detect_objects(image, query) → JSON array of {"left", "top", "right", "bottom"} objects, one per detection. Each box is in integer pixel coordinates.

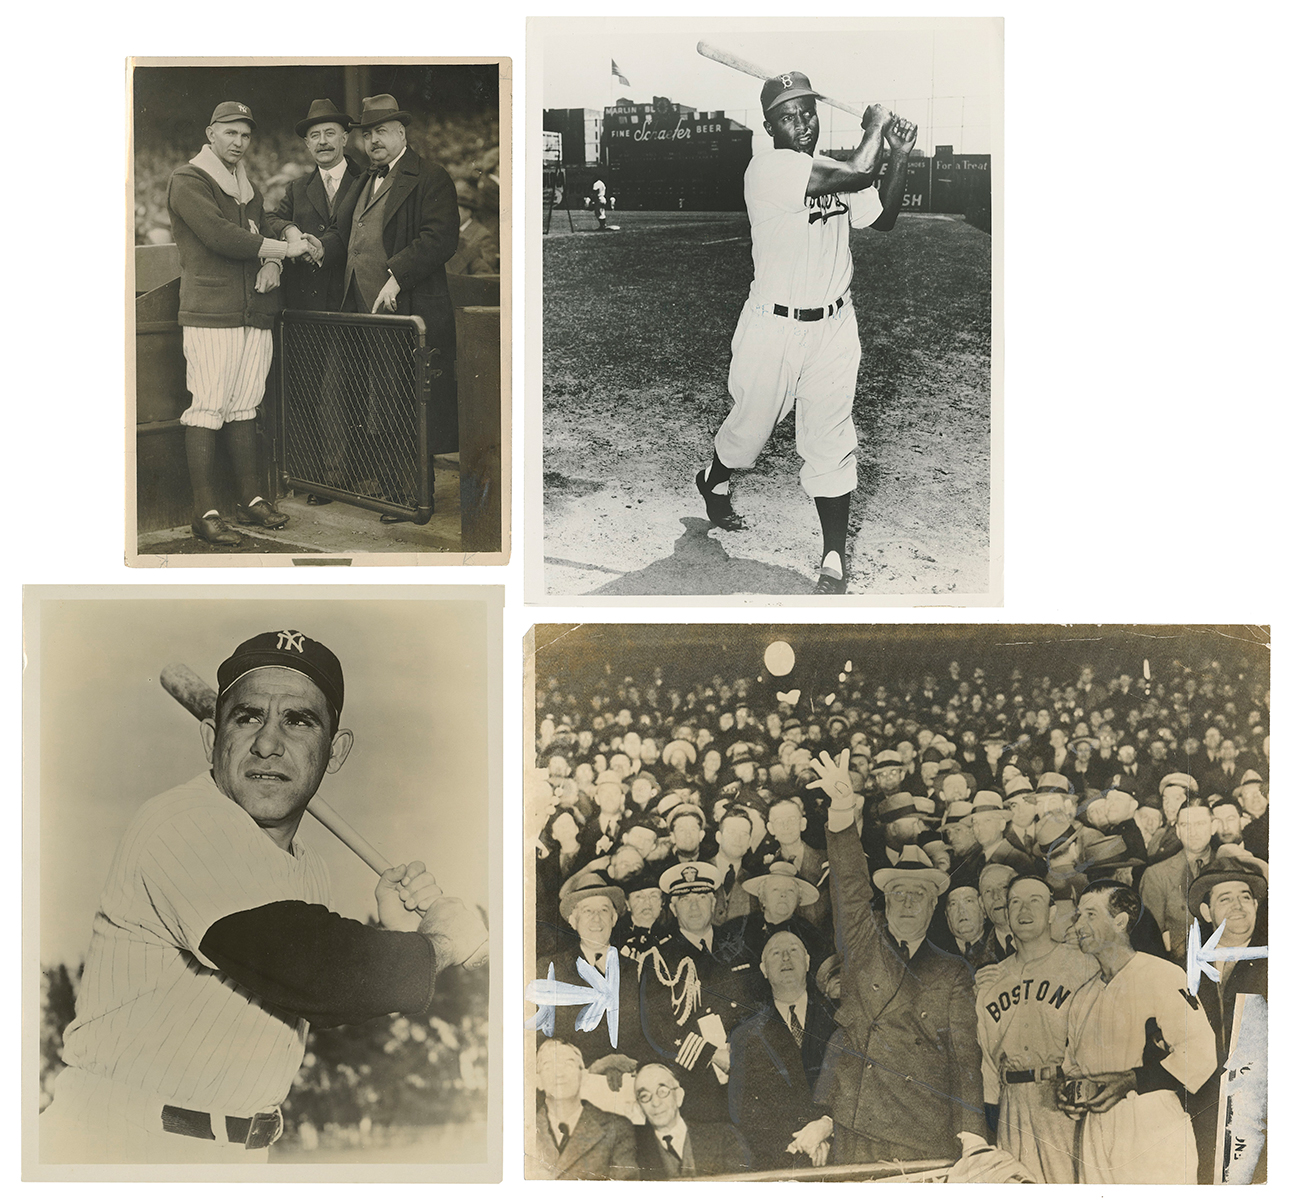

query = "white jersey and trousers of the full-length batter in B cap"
[{"left": 713, "top": 150, "right": 884, "bottom": 497}]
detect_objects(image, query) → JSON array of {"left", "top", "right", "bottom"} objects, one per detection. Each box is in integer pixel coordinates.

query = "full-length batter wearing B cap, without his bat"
[{"left": 695, "top": 71, "right": 916, "bottom": 594}]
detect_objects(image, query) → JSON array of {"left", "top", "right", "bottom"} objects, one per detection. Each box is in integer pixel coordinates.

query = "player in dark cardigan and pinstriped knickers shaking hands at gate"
[{"left": 167, "top": 99, "right": 310, "bottom": 546}]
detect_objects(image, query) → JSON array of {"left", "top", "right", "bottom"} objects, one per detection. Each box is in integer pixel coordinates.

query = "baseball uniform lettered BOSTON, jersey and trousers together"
[{"left": 975, "top": 942, "right": 1099, "bottom": 1183}]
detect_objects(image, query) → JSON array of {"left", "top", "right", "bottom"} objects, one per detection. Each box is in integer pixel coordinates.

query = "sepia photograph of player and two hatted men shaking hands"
[{"left": 127, "top": 58, "right": 512, "bottom": 567}]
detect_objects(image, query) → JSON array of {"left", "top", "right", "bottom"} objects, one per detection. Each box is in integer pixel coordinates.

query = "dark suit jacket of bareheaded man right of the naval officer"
[{"left": 727, "top": 993, "right": 836, "bottom": 1170}]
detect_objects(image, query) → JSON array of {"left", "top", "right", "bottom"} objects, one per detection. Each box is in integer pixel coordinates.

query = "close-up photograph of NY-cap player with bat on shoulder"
[{"left": 25, "top": 589, "right": 501, "bottom": 1181}]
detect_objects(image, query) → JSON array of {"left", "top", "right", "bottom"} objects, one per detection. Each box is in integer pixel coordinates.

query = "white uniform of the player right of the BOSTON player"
[{"left": 1063, "top": 953, "right": 1216, "bottom": 1183}]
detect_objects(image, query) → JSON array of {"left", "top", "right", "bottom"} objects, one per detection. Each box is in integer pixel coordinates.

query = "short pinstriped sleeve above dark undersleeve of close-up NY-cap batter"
[{"left": 136, "top": 801, "right": 325, "bottom": 967}]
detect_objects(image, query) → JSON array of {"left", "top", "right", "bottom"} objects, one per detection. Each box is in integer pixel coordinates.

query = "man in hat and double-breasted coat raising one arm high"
[{"left": 814, "top": 750, "right": 987, "bottom": 1163}]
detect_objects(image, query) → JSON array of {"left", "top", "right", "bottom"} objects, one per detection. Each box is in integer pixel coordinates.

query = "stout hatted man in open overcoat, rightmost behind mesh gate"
[{"left": 337, "top": 94, "right": 457, "bottom": 523}]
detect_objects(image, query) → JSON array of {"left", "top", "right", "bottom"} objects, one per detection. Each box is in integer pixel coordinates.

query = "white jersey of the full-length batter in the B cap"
[{"left": 744, "top": 150, "right": 884, "bottom": 309}]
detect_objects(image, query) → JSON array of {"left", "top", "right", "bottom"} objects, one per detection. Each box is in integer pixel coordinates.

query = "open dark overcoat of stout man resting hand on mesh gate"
[{"left": 324, "top": 146, "right": 457, "bottom": 358}]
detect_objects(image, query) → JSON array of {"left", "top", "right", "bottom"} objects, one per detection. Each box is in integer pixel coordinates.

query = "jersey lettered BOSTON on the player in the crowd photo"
[{"left": 974, "top": 942, "right": 1099, "bottom": 1104}]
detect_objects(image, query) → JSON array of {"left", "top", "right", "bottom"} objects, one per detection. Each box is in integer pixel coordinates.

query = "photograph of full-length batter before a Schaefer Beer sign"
[{"left": 525, "top": 17, "right": 1004, "bottom": 596}]
